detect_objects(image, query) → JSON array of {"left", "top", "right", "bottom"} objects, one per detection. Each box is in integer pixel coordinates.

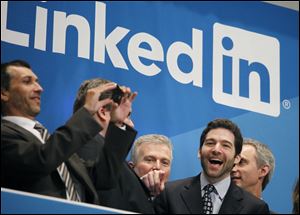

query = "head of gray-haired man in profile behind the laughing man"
[{"left": 231, "top": 138, "right": 275, "bottom": 198}]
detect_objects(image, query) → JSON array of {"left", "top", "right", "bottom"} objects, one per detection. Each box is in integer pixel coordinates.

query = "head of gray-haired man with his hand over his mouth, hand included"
[{"left": 129, "top": 134, "right": 173, "bottom": 197}]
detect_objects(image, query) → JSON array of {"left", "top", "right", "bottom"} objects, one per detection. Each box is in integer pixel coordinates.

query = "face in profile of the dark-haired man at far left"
[{"left": 1, "top": 66, "right": 43, "bottom": 119}]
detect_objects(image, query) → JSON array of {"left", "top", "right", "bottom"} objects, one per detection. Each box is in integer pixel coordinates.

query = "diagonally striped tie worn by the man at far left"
[{"left": 34, "top": 123, "right": 81, "bottom": 202}]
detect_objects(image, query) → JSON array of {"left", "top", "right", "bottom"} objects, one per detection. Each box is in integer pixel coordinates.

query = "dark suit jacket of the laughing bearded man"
[{"left": 154, "top": 175, "right": 269, "bottom": 214}]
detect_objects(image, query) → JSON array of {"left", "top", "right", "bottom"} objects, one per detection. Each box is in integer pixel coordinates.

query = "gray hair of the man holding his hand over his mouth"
[{"left": 131, "top": 134, "right": 173, "bottom": 163}]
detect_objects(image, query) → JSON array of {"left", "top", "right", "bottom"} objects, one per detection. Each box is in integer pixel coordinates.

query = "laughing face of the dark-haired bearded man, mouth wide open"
[{"left": 199, "top": 128, "right": 235, "bottom": 183}]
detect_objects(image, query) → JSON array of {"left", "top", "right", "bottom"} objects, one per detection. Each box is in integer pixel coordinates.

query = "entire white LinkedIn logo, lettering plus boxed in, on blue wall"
[{"left": 1, "top": 1, "right": 280, "bottom": 117}]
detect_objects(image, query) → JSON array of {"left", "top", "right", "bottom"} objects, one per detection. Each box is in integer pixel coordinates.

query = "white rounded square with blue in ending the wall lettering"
[{"left": 213, "top": 23, "right": 280, "bottom": 117}]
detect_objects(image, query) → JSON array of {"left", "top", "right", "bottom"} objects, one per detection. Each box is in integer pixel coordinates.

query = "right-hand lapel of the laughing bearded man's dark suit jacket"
[{"left": 219, "top": 181, "right": 243, "bottom": 214}]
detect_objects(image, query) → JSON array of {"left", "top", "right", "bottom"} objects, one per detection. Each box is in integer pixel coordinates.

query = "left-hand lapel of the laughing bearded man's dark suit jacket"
[{"left": 180, "top": 175, "right": 203, "bottom": 214}]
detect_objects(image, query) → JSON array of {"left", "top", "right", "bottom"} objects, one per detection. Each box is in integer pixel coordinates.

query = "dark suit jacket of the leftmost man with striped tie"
[{"left": 1, "top": 108, "right": 132, "bottom": 204}]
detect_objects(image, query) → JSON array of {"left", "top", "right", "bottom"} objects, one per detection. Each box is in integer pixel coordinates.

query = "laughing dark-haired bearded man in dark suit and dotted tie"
[{"left": 155, "top": 119, "right": 269, "bottom": 214}]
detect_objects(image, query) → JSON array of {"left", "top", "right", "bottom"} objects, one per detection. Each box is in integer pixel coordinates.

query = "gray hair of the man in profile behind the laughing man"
[{"left": 243, "top": 138, "right": 275, "bottom": 190}]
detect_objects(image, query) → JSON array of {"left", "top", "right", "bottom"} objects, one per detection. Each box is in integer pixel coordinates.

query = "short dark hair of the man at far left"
[{"left": 1, "top": 60, "right": 31, "bottom": 116}]
